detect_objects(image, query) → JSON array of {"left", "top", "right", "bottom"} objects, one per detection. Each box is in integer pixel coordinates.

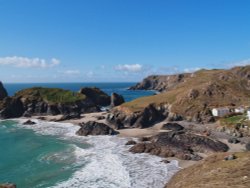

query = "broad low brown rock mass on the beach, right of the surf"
[{"left": 130, "top": 131, "right": 229, "bottom": 160}]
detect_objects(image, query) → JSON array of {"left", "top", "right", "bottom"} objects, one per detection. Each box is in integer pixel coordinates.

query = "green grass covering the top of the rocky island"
[{"left": 15, "top": 87, "right": 86, "bottom": 104}]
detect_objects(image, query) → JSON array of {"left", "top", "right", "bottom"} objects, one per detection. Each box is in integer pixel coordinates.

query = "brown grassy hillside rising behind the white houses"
[{"left": 122, "top": 66, "right": 250, "bottom": 116}]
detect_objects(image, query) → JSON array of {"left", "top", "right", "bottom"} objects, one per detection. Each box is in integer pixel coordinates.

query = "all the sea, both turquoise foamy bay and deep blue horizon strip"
[{"left": 0, "top": 83, "right": 180, "bottom": 188}]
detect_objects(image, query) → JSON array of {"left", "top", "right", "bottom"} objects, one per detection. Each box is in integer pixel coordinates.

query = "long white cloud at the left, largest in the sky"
[{"left": 0, "top": 56, "right": 60, "bottom": 68}]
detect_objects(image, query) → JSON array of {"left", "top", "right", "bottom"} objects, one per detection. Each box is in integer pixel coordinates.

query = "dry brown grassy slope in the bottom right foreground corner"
[{"left": 165, "top": 152, "right": 250, "bottom": 188}]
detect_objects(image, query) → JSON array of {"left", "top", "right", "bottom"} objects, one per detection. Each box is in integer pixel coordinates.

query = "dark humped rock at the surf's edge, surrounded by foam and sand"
[{"left": 76, "top": 121, "right": 119, "bottom": 136}]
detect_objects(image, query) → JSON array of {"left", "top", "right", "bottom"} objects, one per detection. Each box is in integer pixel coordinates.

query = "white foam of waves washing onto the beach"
[{"left": 14, "top": 120, "right": 179, "bottom": 188}]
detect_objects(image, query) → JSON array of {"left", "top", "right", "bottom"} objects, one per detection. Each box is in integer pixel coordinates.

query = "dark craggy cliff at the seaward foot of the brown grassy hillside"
[{"left": 106, "top": 105, "right": 169, "bottom": 129}]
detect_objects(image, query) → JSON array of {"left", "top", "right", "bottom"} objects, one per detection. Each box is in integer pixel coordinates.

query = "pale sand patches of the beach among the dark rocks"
[{"left": 21, "top": 112, "right": 247, "bottom": 169}]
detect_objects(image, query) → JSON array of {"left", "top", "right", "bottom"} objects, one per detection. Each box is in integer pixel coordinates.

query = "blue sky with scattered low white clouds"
[{"left": 0, "top": 0, "right": 250, "bottom": 83}]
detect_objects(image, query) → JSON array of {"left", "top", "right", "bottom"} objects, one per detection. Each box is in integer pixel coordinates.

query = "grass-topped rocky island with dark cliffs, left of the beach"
[{"left": 0, "top": 88, "right": 110, "bottom": 118}]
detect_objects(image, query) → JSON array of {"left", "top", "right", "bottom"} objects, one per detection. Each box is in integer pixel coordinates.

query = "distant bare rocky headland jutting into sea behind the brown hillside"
[{"left": 129, "top": 73, "right": 192, "bottom": 92}]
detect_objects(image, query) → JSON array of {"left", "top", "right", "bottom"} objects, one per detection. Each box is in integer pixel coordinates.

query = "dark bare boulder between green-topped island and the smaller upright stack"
[{"left": 79, "top": 87, "right": 110, "bottom": 106}]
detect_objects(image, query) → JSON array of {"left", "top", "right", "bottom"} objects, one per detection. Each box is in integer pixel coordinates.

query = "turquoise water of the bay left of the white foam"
[{"left": 0, "top": 120, "right": 88, "bottom": 188}]
